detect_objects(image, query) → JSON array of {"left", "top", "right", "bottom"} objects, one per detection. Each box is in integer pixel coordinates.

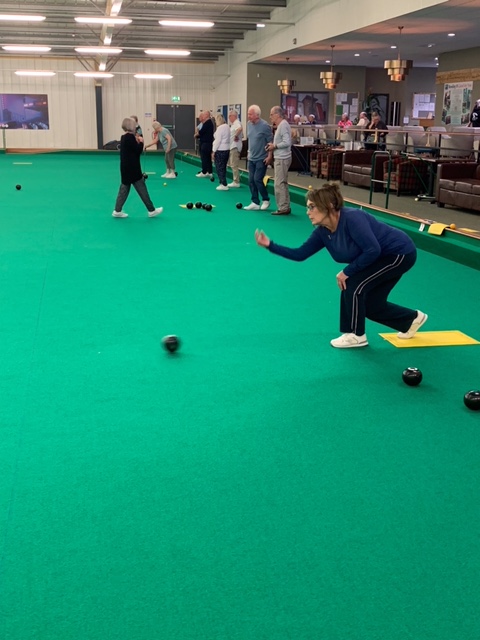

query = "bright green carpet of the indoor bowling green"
[{"left": 0, "top": 152, "right": 480, "bottom": 640}]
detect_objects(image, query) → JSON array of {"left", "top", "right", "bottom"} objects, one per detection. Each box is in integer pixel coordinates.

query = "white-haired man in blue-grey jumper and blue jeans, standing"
[{"left": 244, "top": 104, "right": 273, "bottom": 211}]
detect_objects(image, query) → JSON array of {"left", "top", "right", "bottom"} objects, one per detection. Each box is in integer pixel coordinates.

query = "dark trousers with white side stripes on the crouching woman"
[{"left": 340, "top": 252, "right": 417, "bottom": 336}]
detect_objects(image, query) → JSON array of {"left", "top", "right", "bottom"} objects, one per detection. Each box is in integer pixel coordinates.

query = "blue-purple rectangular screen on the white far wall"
[{"left": 0, "top": 93, "right": 50, "bottom": 131}]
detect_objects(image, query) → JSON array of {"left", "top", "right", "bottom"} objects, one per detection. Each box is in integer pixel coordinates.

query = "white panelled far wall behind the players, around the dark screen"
[{"left": 0, "top": 56, "right": 216, "bottom": 149}]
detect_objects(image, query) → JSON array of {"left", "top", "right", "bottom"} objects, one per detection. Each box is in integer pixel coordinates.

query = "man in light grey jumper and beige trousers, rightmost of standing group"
[{"left": 267, "top": 106, "right": 292, "bottom": 216}]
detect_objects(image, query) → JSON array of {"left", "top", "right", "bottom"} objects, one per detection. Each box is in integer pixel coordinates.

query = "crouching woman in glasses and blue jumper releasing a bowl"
[{"left": 255, "top": 183, "right": 428, "bottom": 349}]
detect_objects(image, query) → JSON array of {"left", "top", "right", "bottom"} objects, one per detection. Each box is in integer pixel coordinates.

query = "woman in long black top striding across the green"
[{"left": 112, "top": 118, "right": 163, "bottom": 218}]
